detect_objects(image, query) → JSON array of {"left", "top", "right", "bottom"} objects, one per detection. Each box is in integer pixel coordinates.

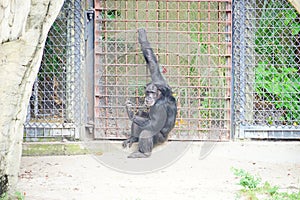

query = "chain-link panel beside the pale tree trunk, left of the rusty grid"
[{"left": 24, "top": 0, "right": 82, "bottom": 139}]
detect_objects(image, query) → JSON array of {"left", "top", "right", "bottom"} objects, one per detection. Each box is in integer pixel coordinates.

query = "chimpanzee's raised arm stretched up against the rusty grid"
[{"left": 138, "top": 28, "right": 167, "bottom": 86}]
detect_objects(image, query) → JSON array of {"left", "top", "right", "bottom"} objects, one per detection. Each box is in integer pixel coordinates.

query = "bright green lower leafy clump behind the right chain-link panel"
[{"left": 255, "top": 61, "right": 300, "bottom": 121}]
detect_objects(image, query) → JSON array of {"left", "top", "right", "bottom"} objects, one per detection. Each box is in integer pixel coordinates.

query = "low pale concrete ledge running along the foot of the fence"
[{"left": 23, "top": 140, "right": 300, "bottom": 163}]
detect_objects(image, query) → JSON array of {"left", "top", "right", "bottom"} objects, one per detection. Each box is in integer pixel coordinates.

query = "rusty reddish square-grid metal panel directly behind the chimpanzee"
[{"left": 95, "top": 0, "right": 231, "bottom": 140}]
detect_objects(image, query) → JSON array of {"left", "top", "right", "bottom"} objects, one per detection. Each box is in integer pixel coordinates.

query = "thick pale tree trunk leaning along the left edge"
[{"left": 0, "top": 0, "right": 63, "bottom": 196}]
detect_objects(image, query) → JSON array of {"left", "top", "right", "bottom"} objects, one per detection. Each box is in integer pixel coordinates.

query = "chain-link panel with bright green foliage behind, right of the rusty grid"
[{"left": 233, "top": 0, "right": 300, "bottom": 138}]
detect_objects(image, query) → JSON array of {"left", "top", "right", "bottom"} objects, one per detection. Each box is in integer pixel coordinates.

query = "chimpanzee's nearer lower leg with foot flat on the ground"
[{"left": 128, "top": 130, "right": 153, "bottom": 158}]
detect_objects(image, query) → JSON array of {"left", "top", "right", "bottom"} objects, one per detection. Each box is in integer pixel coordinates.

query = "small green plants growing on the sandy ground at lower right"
[{"left": 232, "top": 168, "right": 300, "bottom": 200}]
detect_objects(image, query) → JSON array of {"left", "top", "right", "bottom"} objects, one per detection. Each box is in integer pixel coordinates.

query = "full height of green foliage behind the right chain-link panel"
[{"left": 255, "top": 1, "right": 300, "bottom": 124}]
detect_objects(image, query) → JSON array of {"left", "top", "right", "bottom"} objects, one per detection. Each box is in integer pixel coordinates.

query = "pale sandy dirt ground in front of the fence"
[{"left": 17, "top": 142, "right": 300, "bottom": 200}]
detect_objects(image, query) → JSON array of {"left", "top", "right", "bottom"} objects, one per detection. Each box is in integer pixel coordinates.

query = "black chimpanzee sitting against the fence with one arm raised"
[{"left": 123, "top": 29, "right": 177, "bottom": 158}]
